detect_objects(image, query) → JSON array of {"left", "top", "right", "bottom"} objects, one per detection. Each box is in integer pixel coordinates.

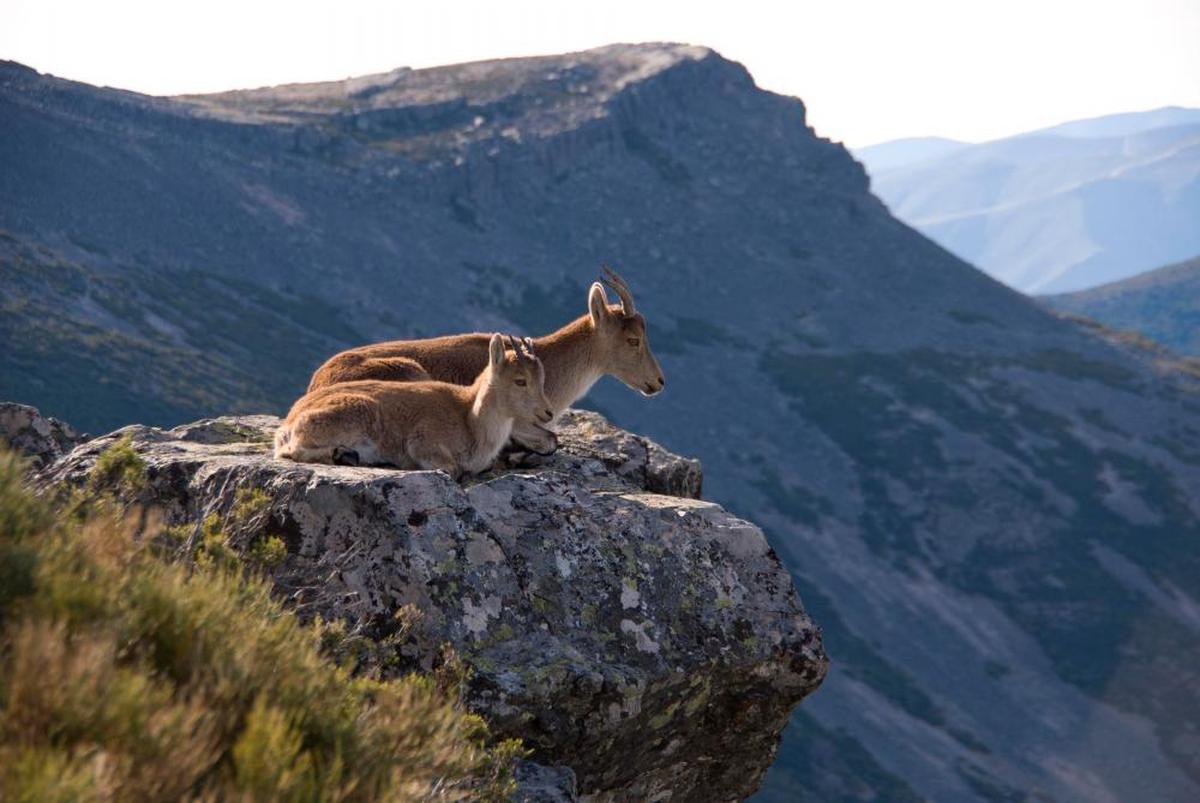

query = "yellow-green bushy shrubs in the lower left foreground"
[{"left": 0, "top": 447, "right": 520, "bottom": 803}]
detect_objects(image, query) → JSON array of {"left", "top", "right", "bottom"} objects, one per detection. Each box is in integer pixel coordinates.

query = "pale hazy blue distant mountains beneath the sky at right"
[{"left": 864, "top": 108, "right": 1200, "bottom": 293}]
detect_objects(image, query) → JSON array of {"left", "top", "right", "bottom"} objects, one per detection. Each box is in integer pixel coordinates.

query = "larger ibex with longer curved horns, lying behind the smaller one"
[{"left": 308, "top": 268, "right": 666, "bottom": 453}]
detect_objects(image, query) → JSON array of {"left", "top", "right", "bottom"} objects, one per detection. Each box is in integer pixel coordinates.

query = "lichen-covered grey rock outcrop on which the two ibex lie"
[{"left": 25, "top": 412, "right": 828, "bottom": 801}]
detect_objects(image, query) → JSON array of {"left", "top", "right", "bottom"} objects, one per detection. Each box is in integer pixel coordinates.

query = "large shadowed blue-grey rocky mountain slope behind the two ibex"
[{"left": 0, "top": 46, "right": 1200, "bottom": 801}]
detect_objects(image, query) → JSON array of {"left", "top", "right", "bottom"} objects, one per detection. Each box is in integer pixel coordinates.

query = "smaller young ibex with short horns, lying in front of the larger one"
[{"left": 275, "top": 335, "right": 554, "bottom": 479}]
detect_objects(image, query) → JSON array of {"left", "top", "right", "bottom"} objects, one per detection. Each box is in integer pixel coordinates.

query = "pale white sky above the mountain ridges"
[{"left": 0, "top": 0, "right": 1200, "bottom": 146}]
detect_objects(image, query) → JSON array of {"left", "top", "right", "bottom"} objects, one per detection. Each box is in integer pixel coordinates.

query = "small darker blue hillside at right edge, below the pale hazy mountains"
[{"left": 1042, "top": 257, "right": 1200, "bottom": 356}]
